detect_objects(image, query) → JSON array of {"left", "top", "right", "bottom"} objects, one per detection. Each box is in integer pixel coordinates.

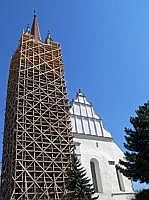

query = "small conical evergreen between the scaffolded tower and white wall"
[{"left": 67, "top": 154, "right": 98, "bottom": 200}]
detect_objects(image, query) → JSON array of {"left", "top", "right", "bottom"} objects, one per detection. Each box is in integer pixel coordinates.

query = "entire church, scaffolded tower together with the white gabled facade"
[{"left": 0, "top": 14, "right": 134, "bottom": 200}]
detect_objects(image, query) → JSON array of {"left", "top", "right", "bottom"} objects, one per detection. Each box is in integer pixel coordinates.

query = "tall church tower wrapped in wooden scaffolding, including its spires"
[{"left": 1, "top": 15, "right": 72, "bottom": 200}]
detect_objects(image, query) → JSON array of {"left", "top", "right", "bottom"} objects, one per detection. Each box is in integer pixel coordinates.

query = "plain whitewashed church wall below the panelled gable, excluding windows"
[{"left": 74, "top": 136, "right": 133, "bottom": 200}]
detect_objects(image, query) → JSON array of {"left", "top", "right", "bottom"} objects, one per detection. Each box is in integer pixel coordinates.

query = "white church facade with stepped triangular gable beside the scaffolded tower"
[{"left": 70, "top": 90, "right": 134, "bottom": 200}]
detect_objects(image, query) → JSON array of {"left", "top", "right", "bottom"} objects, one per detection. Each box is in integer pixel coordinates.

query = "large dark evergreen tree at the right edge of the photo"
[{"left": 118, "top": 102, "right": 149, "bottom": 183}]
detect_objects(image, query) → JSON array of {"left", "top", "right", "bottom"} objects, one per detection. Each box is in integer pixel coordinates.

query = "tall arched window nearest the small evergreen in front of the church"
[{"left": 90, "top": 159, "right": 103, "bottom": 193}]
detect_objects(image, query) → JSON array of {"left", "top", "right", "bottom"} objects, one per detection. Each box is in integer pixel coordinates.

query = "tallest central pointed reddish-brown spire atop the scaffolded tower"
[{"left": 31, "top": 13, "right": 41, "bottom": 40}]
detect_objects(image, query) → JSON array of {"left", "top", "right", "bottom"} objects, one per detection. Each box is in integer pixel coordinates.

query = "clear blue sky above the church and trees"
[{"left": 0, "top": 0, "right": 149, "bottom": 190}]
